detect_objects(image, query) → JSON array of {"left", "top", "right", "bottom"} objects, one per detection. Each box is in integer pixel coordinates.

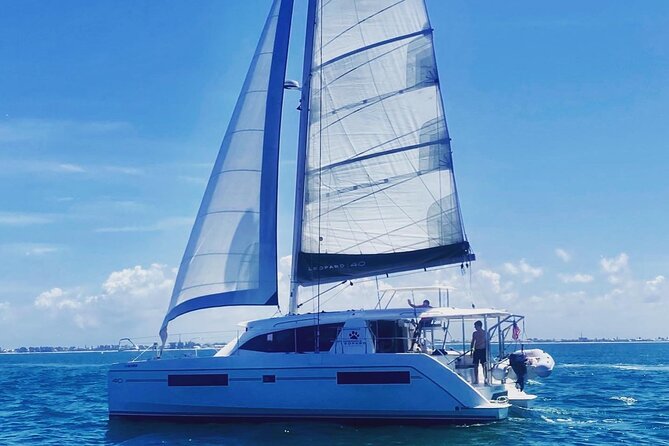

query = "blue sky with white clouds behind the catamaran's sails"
[{"left": 0, "top": 0, "right": 669, "bottom": 348}]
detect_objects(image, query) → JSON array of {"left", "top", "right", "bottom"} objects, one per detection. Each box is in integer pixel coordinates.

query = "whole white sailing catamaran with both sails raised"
[{"left": 108, "top": 0, "right": 553, "bottom": 423}]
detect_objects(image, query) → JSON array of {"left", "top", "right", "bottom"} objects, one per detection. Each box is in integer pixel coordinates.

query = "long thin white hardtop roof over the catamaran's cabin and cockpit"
[{"left": 241, "top": 307, "right": 512, "bottom": 329}]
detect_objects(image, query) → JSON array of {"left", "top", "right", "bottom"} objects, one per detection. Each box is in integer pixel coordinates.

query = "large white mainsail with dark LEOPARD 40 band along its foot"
[{"left": 293, "top": 0, "right": 473, "bottom": 285}]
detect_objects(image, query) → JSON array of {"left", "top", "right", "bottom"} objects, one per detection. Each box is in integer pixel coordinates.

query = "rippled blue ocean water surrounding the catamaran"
[{"left": 0, "top": 343, "right": 669, "bottom": 446}]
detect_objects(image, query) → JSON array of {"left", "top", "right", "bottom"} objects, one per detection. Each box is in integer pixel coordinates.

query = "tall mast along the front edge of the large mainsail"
[{"left": 288, "top": 0, "right": 318, "bottom": 314}]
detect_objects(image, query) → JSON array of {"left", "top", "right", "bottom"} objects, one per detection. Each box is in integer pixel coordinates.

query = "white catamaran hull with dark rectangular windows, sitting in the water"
[{"left": 109, "top": 354, "right": 509, "bottom": 423}]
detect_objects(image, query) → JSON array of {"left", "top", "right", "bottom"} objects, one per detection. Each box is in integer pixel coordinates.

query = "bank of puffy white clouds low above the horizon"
[{"left": 11, "top": 256, "right": 667, "bottom": 344}]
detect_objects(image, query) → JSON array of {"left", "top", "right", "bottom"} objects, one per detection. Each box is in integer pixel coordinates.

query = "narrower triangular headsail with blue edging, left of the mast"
[{"left": 160, "top": 0, "right": 293, "bottom": 343}]
